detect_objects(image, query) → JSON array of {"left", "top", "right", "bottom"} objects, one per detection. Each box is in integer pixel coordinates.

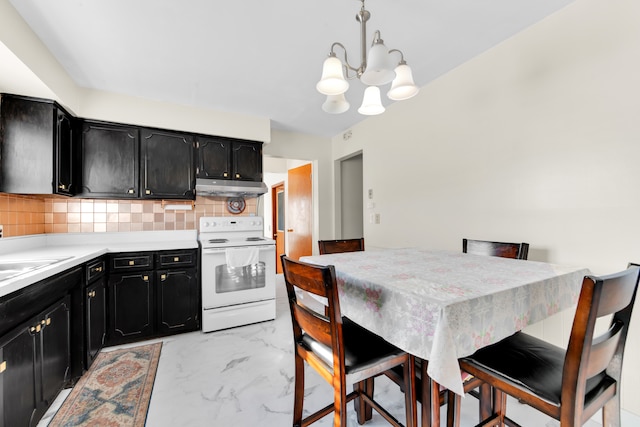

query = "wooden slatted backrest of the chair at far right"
[{"left": 561, "top": 265, "right": 640, "bottom": 425}]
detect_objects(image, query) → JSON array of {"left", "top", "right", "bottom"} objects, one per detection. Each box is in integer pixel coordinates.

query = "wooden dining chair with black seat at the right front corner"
[{"left": 450, "top": 265, "right": 639, "bottom": 427}]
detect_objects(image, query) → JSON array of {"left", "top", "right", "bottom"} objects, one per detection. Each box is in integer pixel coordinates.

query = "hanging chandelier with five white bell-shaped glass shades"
[{"left": 316, "top": 0, "right": 419, "bottom": 116}]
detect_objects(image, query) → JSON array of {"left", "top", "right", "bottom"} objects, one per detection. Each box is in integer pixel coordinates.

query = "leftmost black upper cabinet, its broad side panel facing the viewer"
[{"left": 0, "top": 94, "right": 77, "bottom": 195}]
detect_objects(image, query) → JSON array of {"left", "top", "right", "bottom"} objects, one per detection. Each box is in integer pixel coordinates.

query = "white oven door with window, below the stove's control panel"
[{"left": 202, "top": 245, "right": 276, "bottom": 310}]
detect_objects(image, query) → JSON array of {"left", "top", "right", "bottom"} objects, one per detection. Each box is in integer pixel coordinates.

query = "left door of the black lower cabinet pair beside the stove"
[{"left": 107, "top": 271, "right": 155, "bottom": 344}]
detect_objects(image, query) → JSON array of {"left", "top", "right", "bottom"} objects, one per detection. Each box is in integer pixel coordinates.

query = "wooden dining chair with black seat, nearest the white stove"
[{"left": 281, "top": 255, "right": 417, "bottom": 427}]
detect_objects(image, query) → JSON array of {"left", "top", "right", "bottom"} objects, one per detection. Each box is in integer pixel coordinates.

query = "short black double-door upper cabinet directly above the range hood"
[{"left": 196, "top": 136, "right": 262, "bottom": 181}]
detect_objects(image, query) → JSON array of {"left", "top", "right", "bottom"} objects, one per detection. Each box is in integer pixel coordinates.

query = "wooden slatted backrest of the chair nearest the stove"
[{"left": 281, "top": 255, "right": 344, "bottom": 376}]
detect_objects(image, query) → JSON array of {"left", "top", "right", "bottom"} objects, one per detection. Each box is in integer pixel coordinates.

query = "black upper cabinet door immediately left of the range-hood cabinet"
[{"left": 140, "top": 129, "right": 196, "bottom": 199}]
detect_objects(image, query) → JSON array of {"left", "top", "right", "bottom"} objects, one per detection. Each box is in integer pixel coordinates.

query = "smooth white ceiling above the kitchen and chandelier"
[{"left": 9, "top": 0, "right": 573, "bottom": 137}]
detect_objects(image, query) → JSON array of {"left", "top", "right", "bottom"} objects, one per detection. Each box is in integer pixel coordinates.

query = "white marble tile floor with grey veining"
[{"left": 38, "top": 275, "right": 630, "bottom": 427}]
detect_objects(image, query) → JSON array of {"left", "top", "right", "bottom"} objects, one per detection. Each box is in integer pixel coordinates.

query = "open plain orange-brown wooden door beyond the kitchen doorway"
[{"left": 287, "top": 163, "right": 313, "bottom": 260}]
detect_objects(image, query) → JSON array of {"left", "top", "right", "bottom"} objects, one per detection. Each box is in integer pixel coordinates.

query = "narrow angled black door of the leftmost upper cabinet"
[{"left": 54, "top": 108, "right": 75, "bottom": 196}]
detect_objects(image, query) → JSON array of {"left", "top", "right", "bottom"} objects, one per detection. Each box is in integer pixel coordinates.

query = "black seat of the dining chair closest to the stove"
[{"left": 302, "top": 317, "right": 404, "bottom": 375}]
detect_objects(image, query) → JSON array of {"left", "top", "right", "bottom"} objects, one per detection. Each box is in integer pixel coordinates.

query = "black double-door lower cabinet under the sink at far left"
[{"left": 0, "top": 295, "right": 71, "bottom": 427}]
